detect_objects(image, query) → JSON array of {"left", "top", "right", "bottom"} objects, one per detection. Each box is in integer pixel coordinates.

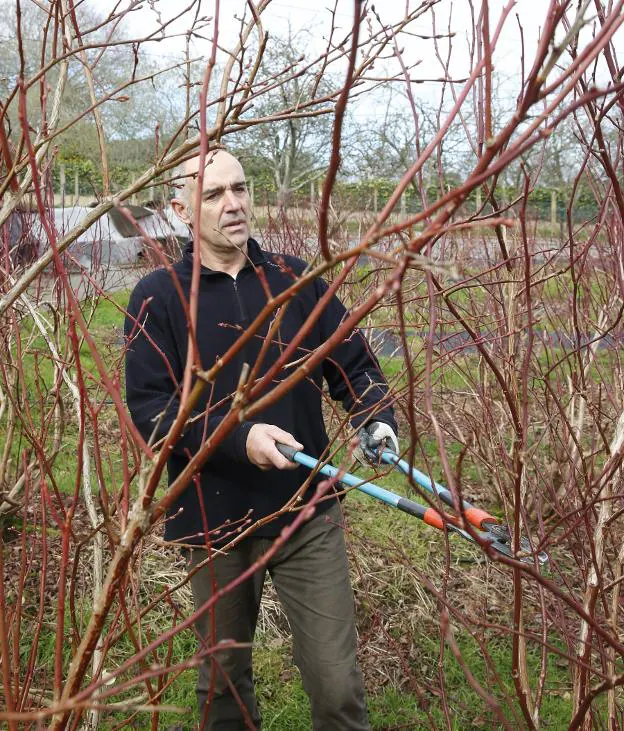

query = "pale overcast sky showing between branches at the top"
[{"left": 123, "top": 0, "right": 623, "bottom": 123}]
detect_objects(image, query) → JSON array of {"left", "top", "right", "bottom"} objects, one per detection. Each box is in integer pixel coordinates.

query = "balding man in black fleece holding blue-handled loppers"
[{"left": 126, "top": 150, "right": 398, "bottom": 730}]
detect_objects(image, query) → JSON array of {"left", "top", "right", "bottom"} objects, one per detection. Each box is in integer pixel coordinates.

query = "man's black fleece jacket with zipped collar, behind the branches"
[{"left": 125, "top": 239, "right": 396, "bottom": 545}]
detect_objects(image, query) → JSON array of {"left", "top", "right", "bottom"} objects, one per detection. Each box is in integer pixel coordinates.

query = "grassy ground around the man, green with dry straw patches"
[{"left": 0, "top": 292, "right": 600, "bottom": 731}]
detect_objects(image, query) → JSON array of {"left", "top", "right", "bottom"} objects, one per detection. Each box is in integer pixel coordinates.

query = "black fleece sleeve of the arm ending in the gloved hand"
[{"left": 316, "top": 279, "right": 397, "bottom": 433}]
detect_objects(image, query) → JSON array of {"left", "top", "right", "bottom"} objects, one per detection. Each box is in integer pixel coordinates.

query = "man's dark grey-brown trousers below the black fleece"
[{"left": 188, "top": 503, "right": 370, "bottom": 731}]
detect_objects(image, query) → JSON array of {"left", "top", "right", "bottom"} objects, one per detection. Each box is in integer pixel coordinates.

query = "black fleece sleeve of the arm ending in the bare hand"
[{"left": 124, "top": 283, "right": 253, "bottom": 462}]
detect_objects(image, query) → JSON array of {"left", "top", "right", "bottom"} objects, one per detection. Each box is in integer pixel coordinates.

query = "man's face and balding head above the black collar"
[{"left": 172, "top": 150, "right": 250, "bottom": 252}]
